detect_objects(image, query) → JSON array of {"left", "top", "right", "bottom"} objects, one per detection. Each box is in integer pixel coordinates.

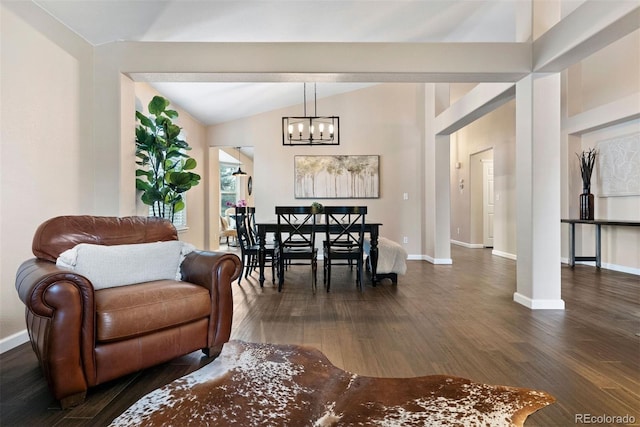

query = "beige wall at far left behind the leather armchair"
[{"left": 0, "top": 3, "right": 93, "bottom": 338}]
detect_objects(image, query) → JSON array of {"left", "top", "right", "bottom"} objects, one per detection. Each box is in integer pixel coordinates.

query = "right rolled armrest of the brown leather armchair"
[{"left": 181, "top": 251, "right": 241, "bottom": 356}]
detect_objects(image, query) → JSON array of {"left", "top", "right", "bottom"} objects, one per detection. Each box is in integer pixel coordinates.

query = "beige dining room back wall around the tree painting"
[{"left": 207, "top": 83, "right": 423, "bottom": 255}]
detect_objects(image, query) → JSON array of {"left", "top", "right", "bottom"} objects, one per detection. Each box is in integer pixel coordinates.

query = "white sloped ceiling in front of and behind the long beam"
[{"left": 34, "top": 0, "right": 529, "bottom": 125}]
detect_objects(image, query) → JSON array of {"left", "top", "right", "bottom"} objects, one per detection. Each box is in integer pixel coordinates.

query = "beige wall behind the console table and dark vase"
[{"left": 562, "top": 30, "right": 640, "bottom": 274}]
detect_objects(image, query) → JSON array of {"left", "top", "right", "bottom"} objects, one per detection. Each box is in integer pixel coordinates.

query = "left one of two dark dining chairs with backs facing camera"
[{"left": 276, "top": 206, "right": 318, "bottom": 292}]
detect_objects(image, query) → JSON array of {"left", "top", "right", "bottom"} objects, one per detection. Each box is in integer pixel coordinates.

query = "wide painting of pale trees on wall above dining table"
[{"left": 293, "top": 154, "right": 380, "bottom": 199}]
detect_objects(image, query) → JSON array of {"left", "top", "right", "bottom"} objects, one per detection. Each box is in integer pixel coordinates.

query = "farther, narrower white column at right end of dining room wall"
[{"left": 424, "top": 83, "right": 452, "bottom": 264}]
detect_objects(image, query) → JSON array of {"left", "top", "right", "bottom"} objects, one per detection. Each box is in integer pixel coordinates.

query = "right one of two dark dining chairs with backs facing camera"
[{"left": 323, "top": 206, "right": 367, "bottom": 292}]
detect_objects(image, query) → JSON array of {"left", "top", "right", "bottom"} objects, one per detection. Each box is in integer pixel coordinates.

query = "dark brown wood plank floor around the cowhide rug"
[{"left": 0, "top": 246, "right": 640, "bottom": 427}]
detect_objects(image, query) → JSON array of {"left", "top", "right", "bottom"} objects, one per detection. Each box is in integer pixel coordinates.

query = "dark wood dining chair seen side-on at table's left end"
[{"left": 234, "top": 206, "right": 276, "bottom": 286}]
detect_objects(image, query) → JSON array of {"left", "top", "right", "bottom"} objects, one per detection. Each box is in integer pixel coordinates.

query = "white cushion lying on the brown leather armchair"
[{"left": 56, "top": 240, "right": 195, "bottom": 289}]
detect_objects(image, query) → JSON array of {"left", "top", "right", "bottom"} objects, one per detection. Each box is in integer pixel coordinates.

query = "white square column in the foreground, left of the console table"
[{"left": 513, "top": 73, "right": 564, "bottom": 309}]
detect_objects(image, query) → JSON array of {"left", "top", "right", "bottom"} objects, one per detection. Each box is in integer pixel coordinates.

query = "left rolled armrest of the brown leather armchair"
[{"left": 16, "top": 259, "right": 96, "bottom": 407}]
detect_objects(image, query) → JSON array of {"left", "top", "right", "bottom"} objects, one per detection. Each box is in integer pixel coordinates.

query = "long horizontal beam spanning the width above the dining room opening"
[{"left": 106, "top": 42, "right": 531, "bottom": 82}]
